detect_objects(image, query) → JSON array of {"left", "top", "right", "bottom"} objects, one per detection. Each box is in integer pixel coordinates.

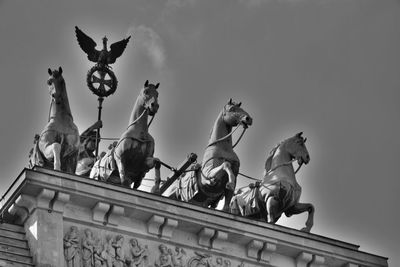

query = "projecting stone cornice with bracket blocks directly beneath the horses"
[{"left": 3, "top": 168, "right": 387, "bottom": 266}]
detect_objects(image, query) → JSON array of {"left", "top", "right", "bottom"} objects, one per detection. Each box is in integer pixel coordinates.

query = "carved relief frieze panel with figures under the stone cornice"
[{"left": 64, "top": 225, "right": 262, "bottom": 267}]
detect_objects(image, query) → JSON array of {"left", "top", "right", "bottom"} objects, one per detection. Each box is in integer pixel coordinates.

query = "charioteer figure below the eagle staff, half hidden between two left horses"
[{"left": 75, "top": 121, "right": 103, "bottom": 177}]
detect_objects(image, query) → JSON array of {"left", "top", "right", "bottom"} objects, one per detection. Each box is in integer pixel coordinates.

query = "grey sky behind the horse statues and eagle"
[{"left": 0, "top": 0, "right": 400, "bottom": 266}]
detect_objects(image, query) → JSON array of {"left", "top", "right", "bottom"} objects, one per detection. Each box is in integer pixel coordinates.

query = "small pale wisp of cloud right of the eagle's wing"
[{"left": 128, "top": 25, "right": 166, "bottom": 69}]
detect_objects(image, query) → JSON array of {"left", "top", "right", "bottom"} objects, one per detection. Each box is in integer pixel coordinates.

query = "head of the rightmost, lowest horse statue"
[{"left": 282, "top": 132, "right": 310, "bottom": 165}]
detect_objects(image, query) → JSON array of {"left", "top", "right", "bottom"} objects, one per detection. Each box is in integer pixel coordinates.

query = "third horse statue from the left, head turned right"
[{"left": 169, "top": 99, "right": 253, "bottom": 211}]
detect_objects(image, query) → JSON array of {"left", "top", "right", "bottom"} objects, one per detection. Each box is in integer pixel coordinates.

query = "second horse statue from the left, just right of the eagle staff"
[{"left": 90, "top": 81, "right": 160, "bottom": 189}]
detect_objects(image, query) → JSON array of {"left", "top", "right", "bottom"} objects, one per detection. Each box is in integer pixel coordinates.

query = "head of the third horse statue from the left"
[{"left": 223, "top": 98, "right": 253, "bottom": 128}]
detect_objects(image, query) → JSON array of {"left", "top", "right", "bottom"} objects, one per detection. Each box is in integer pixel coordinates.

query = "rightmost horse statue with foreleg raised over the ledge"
[{"left": 230, "top": 132, "right": 314, "bottom": 232}]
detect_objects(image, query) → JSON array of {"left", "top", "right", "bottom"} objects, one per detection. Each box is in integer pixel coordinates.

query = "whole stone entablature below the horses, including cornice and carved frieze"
[{"left": 2, "top": 168, "right": 387, "bottom": 267}]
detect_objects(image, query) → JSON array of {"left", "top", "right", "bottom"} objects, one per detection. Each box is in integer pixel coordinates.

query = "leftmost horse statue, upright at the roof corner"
[{"left": 30, "top": 67, "right": 79, "bottom": 173}]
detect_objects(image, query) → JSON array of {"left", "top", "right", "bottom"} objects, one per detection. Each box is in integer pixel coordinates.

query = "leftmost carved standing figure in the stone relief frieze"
[{"left": 64, "top": 226, "right": 81, "bottom": 267}]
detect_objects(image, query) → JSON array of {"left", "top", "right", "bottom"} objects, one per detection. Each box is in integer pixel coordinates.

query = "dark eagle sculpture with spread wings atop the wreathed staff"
[{"left": 75, "top": 26, "right": 131, "bottom": 66}]
